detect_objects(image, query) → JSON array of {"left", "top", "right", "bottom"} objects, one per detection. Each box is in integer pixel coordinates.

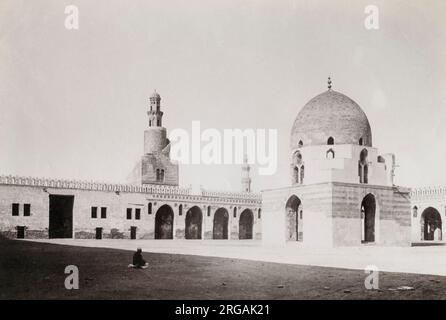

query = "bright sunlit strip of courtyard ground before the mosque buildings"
[{"left": 27, "top": 239, "right": 446, "bottom": 276}]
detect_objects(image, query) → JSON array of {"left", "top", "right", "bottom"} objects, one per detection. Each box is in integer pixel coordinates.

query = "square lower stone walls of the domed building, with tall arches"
[{"left": 262, "top": 183, "right": 411, "bottom": 247}]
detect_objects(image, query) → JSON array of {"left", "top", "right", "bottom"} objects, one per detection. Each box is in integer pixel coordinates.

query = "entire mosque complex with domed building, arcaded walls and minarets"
[{"left": 0, "top": 78, "right": 446, "bottom": 247}]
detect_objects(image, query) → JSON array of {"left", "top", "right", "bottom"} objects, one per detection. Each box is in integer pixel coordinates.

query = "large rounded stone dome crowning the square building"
[{"left": 291, "top": 89, "right": 372, "bottom": 149}]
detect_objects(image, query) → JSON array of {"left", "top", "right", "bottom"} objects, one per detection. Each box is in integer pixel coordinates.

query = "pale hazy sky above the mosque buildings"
[{"left": 0, "top": 0, "right": 446, "bottom": 191}]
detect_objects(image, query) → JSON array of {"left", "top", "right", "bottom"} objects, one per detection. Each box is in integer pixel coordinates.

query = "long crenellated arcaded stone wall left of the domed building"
[{"left": 0, "top": 177, "right": 261, "bottom": 239}]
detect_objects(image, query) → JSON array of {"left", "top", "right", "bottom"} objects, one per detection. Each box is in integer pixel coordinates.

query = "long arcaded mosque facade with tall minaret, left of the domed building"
[{"left": 0, "top": 92, "right": 262, "bottom": 240}]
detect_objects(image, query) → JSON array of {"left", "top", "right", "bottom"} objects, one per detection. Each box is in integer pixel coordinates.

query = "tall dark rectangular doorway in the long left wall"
[{"left": 48, "top": 195, "right": 74, "bottom": 238}]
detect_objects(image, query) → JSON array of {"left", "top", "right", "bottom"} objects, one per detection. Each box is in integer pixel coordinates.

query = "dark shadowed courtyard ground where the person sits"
[{"left": 0, "top": 240, "right": 446, "bottom": 300}]
